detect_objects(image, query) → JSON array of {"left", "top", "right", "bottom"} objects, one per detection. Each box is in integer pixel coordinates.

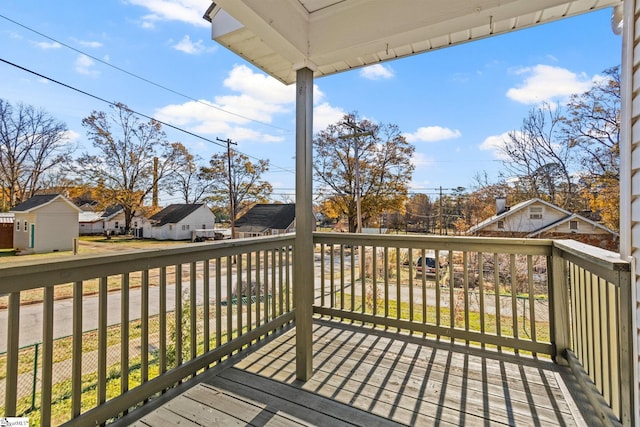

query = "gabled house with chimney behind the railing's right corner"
[{"left": 467, "top": 198, "right": 618, "bottom": 250}]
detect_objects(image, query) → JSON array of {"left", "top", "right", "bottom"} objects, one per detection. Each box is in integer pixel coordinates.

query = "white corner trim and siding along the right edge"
[{"left": 620, "top": 0, "right": 640, "bottom": 425}]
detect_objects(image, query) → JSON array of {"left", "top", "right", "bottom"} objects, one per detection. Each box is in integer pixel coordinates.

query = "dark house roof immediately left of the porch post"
[{"left": 235, "top": 203, "right": 296, "bottom": 233}]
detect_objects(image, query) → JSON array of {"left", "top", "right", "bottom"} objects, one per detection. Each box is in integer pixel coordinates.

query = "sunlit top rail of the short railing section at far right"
[{"left": 553, "top": 240, "right": 631, "bottom": 272}]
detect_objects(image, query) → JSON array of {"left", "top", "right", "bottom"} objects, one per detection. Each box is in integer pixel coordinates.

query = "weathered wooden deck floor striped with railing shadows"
[{"left": 117, "top": 320, "right": 600, "bottom": 427}]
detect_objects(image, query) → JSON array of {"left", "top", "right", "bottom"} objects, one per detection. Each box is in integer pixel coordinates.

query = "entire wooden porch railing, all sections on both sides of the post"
[{"left": 0, "top": 233, "right": 636, "bottom": 426}]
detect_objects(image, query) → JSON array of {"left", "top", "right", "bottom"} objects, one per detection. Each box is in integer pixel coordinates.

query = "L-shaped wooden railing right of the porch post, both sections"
[{"left": 314, "top": 233, "right": 635, "bottom": 426}]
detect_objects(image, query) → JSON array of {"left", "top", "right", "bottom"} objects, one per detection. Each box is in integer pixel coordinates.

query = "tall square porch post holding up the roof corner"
[{"left": 293, "top": 68, "right": 314, "bottom": 381}]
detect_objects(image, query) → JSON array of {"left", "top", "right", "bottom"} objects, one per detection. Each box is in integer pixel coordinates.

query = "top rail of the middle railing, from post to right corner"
[{"left": 313, "top": 232, "right": 553, "bottom": 256}]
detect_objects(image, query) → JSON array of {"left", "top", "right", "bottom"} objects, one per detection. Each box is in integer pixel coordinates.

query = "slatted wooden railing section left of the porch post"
[{"left": 0, "top": 236, "right": 294, "bottom": 425}]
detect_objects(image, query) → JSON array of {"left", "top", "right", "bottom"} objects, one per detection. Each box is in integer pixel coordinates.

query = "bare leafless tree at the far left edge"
[{"left": 0, "top": 99, "right": 74, "bottom": 206}]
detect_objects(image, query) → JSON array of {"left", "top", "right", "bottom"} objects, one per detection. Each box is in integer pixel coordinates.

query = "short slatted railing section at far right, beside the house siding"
[{"left": 553, "top": 240, "right": 636, "bottom": 426}]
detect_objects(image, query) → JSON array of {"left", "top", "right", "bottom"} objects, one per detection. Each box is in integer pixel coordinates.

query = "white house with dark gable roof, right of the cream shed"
[{"left": 143, "top": 203, "right": 215, "bottom": 240}]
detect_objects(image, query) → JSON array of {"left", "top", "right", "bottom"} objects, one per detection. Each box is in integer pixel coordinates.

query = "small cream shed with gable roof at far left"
[{"left": 11, "top": 194, "right": 81, "bottom": 253}]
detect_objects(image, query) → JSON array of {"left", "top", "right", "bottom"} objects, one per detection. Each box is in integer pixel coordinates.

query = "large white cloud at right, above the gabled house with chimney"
[{"left": 507, "top": 65, "right": 593, "bottom": 104}]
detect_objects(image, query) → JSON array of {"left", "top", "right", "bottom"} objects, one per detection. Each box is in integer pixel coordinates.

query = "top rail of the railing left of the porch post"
[{"left": 0, "top": 234, "right": 295, "bottom": 293}]
